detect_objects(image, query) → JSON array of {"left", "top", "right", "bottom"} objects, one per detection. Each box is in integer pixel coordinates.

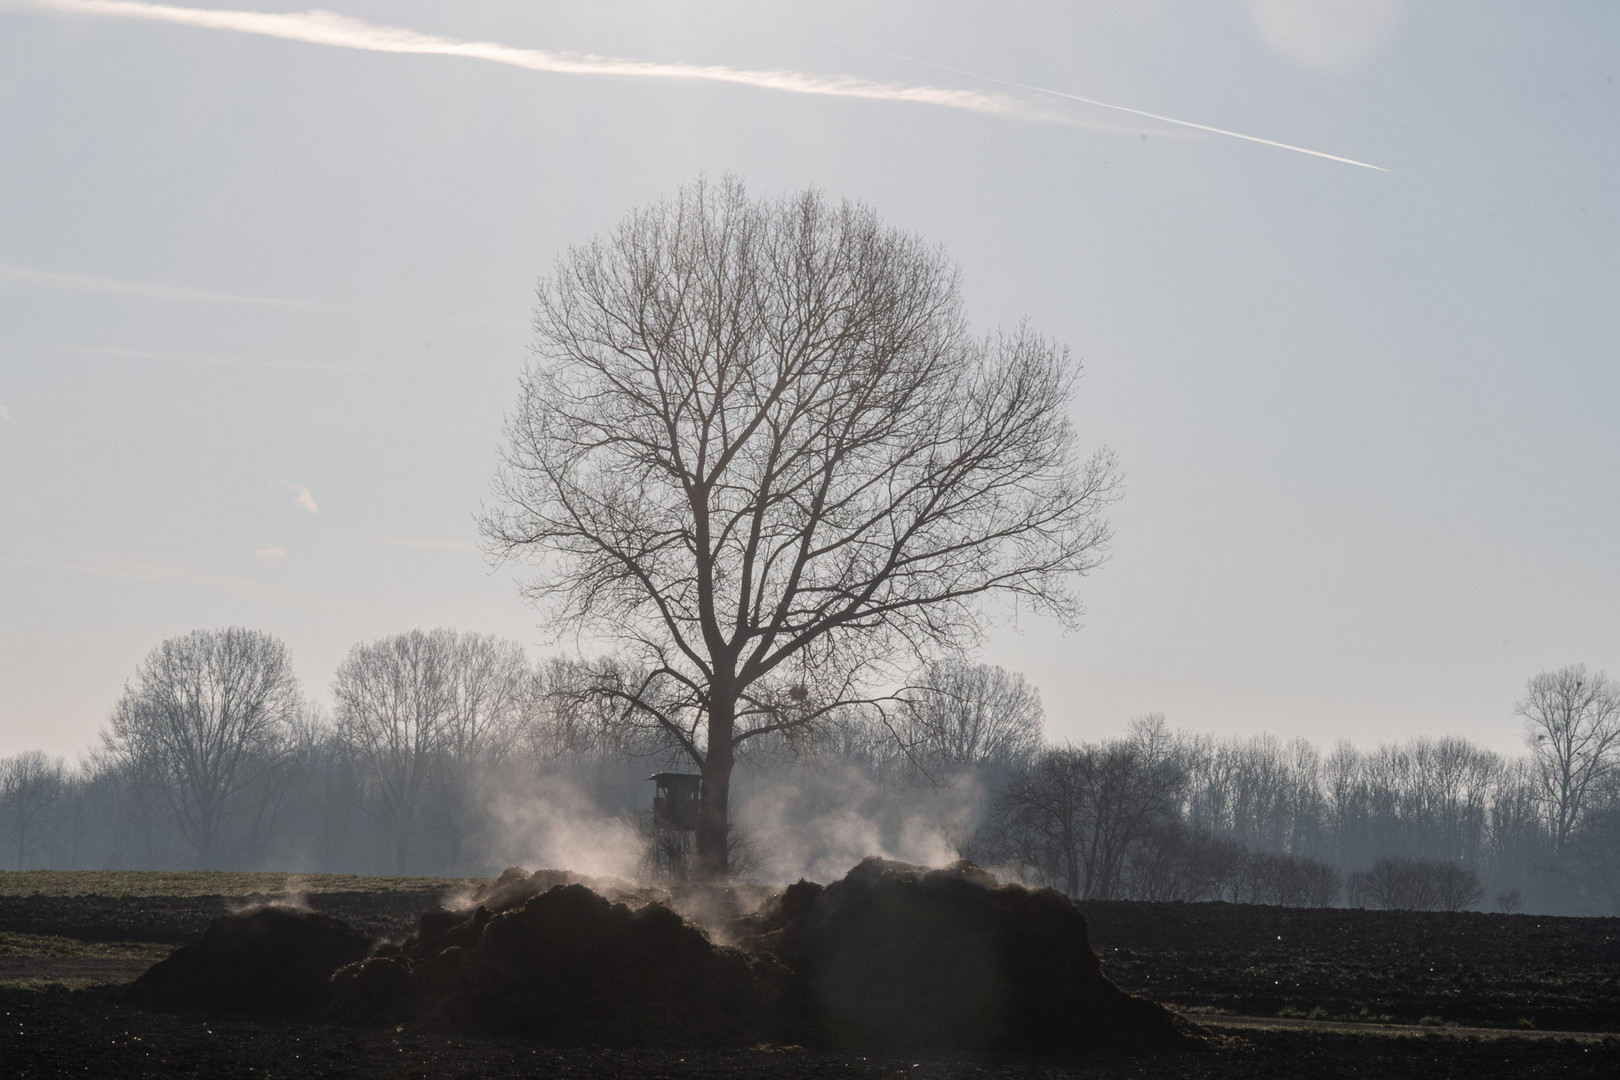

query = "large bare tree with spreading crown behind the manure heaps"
[{"left": 483, "top": 180, "right": 1116, "bottom": 876}]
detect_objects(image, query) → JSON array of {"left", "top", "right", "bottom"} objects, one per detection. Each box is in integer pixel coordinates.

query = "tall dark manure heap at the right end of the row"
[{"left": 739, "top": 858, "right": 1196, "bottom": 1052}]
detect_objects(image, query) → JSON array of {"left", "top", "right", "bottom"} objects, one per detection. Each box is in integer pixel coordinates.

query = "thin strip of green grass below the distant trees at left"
[{"left": 0, "top": 870, "right": 484, "bottom": 897}]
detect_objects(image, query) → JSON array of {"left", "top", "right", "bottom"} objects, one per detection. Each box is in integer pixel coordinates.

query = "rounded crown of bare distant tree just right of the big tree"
[{"left": 901, "top": 661, "right": 1045, "bottom": 767}]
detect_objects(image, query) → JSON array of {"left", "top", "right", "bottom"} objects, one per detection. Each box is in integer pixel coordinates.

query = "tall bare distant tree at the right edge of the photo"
[{"left": 1513, "top": 664, "right": 1620, "bottom": 855}]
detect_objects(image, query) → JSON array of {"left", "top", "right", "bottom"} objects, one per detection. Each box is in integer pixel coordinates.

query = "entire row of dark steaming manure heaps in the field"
[{"left": 130, "top": 858, "right": 1199, "bottom": 1052}]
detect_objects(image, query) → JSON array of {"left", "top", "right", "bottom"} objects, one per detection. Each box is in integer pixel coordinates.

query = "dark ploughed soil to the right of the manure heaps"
[{"left": 1081, "top": 902, "right": 1620, "bottom": 1031}]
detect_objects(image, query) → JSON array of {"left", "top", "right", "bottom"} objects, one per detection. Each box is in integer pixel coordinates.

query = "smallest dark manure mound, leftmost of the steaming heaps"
[{"left": 130, "top": 907, "right": 373, "bottom": 1017}]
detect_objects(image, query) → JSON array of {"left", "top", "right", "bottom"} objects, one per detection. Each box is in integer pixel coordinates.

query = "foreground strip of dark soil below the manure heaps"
[{"left": 0, "top": 988, "right": 1620, "bottom": 1080}]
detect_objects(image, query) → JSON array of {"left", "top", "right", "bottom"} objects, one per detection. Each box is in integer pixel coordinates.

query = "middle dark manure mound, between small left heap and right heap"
[{"left": 329, "top": 884, "right": 786, "bottom": 1044}]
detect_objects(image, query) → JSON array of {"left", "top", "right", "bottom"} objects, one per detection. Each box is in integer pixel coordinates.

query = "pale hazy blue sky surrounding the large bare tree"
[{"left": 0, "top": 0, "right": 1620, "bottom": 755}]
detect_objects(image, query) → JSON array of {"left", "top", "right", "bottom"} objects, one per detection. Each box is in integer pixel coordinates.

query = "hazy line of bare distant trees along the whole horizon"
[{"left": 0, "top": 628, "right": 1620, "bottom": 915}]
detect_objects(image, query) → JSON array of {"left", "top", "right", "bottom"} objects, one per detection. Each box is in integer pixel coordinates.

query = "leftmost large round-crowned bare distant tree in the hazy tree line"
[{"left": 102, "top": 627, "right": 303, "bottom": 868}]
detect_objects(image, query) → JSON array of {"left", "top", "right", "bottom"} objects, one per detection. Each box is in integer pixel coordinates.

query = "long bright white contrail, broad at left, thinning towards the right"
[{"left": 0, "top": 0, "right": 1388, "bottom": 172}]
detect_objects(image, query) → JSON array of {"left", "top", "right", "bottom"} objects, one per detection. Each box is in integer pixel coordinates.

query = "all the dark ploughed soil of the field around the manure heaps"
[{"left": 0, "top": 889, "right": 1620, "bottom": 1080}]
